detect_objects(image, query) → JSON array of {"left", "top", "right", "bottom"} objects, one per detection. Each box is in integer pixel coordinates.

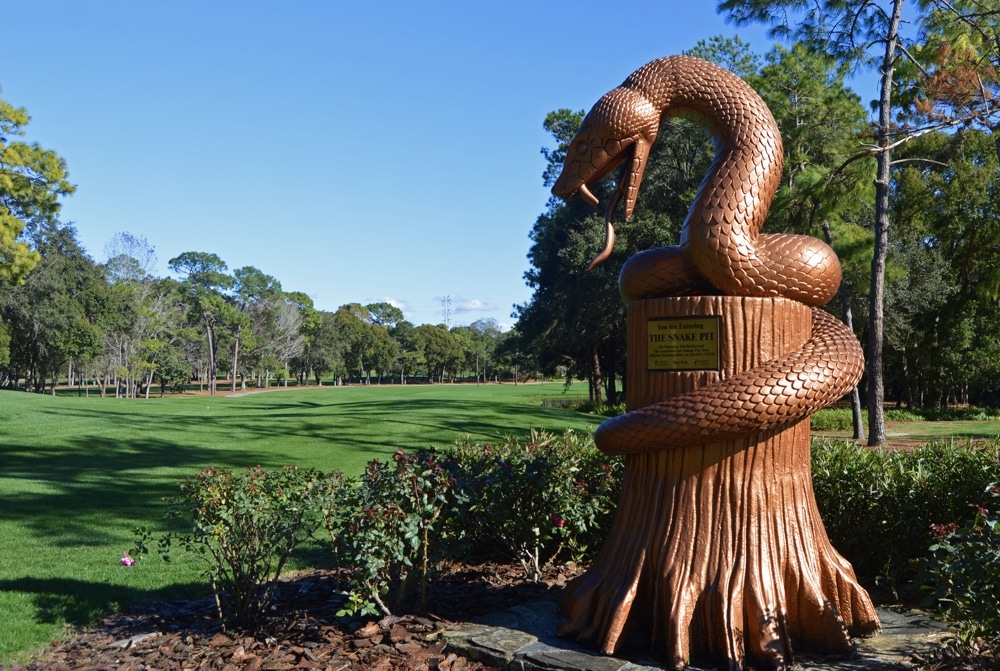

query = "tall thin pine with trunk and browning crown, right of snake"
[{"left": 718, "top": 0, "right": 1000, "bottom": 445}]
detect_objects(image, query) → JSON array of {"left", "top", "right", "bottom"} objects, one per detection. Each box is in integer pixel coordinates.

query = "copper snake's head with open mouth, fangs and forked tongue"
[{"left": 552, "top": 87, "right": 660, "bottom": 268}]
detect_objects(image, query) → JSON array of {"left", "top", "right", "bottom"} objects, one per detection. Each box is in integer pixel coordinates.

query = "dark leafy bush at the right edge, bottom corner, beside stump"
[{"left": 922, "top": 483, "right": 1000, "bottom": 639}]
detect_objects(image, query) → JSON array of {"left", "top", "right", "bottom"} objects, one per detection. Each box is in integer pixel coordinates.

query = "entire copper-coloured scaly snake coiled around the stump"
[{"left": 552, "top": 56, "right": 864, "bottom": 454}]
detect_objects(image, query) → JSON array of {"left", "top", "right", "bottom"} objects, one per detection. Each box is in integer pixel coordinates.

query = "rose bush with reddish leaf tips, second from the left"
[{"left": 321, "top": 450, "right": 456, "bottom": 615}]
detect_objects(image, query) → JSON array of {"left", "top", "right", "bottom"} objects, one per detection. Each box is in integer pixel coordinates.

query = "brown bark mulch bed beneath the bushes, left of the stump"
[{"left": 0, "top": 564, "right": 578, "bottom": 671}]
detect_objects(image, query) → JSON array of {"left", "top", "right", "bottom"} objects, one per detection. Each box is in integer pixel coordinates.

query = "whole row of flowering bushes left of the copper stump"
[{"left": 141, "top": 432, "right": 620, "bottom": 628}]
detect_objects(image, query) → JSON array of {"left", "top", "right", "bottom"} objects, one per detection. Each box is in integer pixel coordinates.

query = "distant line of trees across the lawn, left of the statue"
[{"left": 0, "top": 220, "right": 514, "bottom": 398}]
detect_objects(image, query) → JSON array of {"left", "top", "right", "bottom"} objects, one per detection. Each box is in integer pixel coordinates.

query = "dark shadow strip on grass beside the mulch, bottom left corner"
[{"left": 0, "top": 577, "right": 206, "bottom": 627}]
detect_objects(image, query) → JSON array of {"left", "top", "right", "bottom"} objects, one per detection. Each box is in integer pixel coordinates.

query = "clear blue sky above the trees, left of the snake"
[{"left": 0, "top": 0, "right": 796, "bottom": 325}]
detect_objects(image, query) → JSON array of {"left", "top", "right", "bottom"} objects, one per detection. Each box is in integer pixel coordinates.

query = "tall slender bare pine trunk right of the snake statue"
[{"left": 867, "top": 0, "right": 903, "bottom": 447}]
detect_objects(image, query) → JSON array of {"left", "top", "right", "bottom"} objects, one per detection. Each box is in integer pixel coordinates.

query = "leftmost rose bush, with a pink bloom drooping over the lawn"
[{"left": 133, "top": 466, "right": 321, "bottom": 629}]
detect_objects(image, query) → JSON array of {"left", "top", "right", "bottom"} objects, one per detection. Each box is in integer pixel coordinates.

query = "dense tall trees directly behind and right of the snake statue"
[{"left": 517, "top": 0, "right": 1000, "bottom": 444}]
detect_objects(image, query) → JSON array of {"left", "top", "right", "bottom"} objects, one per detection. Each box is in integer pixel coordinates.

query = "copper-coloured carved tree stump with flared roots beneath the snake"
[{"left": 559, "top": 296, "right": 879, "bottom": 668}]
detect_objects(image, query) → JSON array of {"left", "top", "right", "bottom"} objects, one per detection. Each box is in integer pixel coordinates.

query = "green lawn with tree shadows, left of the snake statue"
[{"left": 0, "top": 383, "right": 600, "bottom": 663}]
